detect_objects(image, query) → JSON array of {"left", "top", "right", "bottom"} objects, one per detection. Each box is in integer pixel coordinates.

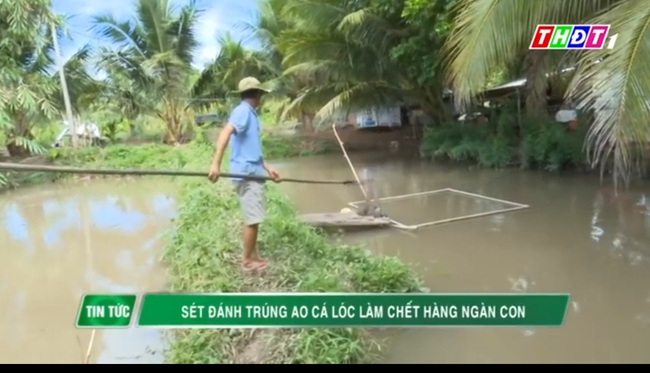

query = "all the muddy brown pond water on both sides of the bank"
[{"left": 0, "top": 154, "right": 650, "bottom": 363}]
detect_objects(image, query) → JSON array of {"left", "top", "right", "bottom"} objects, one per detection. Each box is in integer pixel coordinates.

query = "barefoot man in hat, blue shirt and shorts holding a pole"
[{"left": 209, "top": 77, "right": 280, "bottom": 271}]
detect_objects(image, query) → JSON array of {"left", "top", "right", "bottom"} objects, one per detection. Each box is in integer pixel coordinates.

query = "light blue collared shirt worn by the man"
[{"left": 228, "top": 101, "right": 266, "bottom": 182}]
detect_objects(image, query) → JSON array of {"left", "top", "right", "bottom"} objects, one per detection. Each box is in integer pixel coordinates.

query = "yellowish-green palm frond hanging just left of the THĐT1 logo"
[{"left": 444, "top": 0, "right": 613, "bottom": 106}]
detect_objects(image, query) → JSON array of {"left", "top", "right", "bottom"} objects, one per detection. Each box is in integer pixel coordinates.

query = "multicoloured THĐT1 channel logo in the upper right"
[{"left": 529, "top": 25, "right": 618, "bottom": 49}]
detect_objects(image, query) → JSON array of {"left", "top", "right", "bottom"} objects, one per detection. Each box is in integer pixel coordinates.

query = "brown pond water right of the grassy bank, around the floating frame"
[{"left": 280, "top": 155, "right": 650, "bottom": 363}]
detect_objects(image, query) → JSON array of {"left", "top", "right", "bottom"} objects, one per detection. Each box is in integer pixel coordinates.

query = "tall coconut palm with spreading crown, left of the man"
[{"left": 94, "top": 0, "right": 200, "bottom": 143}]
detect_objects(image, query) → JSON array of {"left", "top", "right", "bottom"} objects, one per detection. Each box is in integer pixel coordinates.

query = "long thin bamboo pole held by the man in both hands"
[{"left": 0, "top": 163, "right": 359, "bottom": 185}]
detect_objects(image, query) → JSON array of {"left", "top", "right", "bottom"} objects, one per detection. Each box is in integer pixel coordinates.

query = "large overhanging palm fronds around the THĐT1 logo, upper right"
[{"left": 446, "top": 0, "right": 650, "bottom": 185}]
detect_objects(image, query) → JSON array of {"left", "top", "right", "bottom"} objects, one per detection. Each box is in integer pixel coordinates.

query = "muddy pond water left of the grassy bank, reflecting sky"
[{"left": 0, "top": 180, "right": 176, "bottom": 363}]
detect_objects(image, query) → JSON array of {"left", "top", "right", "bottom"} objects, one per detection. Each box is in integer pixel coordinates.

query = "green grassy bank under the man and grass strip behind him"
[{"left": 15, "top": 142, "right": 420, "bottom": 363}]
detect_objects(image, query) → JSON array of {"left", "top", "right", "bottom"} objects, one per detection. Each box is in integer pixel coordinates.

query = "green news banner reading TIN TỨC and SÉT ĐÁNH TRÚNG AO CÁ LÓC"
[{"left": 77, "top": 293, "right": 569, "bottom": 329}]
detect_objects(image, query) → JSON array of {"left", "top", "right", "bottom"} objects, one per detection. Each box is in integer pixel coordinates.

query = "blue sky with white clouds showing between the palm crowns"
[{"left": 53, "top": 0, "right": 257, "bottom": 68}]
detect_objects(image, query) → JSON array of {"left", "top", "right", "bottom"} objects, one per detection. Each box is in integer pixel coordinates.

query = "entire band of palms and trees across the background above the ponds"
[{"left": 0, "top": 0, "right": 650, "bottom": 184}]
